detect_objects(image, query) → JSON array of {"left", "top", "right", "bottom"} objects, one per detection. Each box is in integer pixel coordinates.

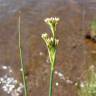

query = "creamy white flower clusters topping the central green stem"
[{"left": 41, "top": 17, "right": 59, "bottom": 48}]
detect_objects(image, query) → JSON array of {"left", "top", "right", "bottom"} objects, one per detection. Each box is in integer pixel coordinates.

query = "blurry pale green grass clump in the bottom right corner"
[{"left": 78, "top": 66, "right": 96, "bottom": 96}]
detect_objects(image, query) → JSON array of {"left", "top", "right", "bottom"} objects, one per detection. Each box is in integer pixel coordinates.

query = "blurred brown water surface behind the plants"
[{"left": 0, "top": 0, "right": 96, "bottom": 96}]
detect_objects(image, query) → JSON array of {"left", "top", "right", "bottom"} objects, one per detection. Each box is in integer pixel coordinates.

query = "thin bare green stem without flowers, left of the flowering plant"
[{"left": 18, "top": 16, "right": 28, "bottom": 96}]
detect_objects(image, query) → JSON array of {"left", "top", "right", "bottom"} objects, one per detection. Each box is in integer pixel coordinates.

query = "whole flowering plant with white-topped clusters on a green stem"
[{"left": 41, "top": 17, "right": 59, "bottom": 96}]
